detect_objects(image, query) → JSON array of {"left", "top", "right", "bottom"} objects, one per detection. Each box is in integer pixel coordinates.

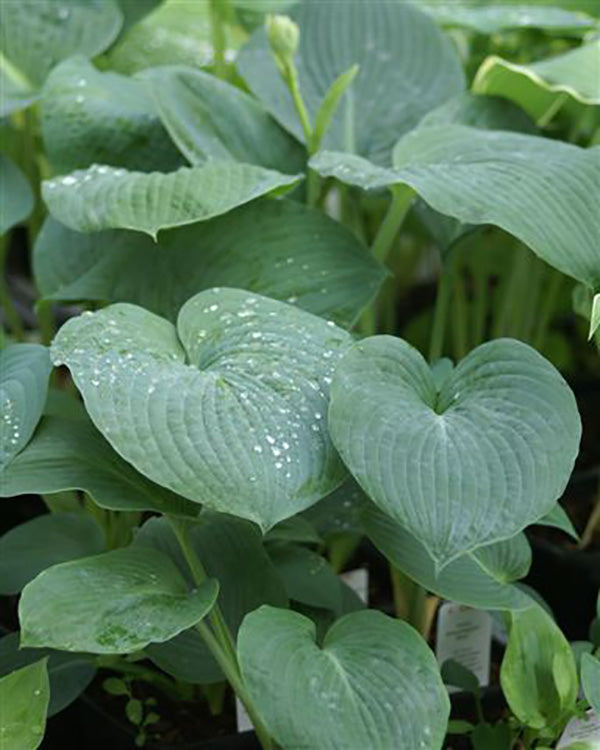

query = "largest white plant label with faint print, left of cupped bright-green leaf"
[{"left": 435, "top": 602, "right": 493, "bottom": 692}]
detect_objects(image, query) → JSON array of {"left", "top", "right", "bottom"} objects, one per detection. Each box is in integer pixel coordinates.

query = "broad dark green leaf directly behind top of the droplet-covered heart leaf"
[{"left": 34, "top": 199, "right": 385, "bottom": 326}]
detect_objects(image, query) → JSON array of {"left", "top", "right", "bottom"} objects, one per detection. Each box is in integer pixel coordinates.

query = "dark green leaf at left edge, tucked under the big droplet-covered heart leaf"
[{"left": 0, "top": 417, "right": 198, "bottom": 516}]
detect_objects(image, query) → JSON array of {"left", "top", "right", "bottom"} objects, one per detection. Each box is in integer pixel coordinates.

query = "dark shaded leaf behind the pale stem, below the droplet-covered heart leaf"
[{"left": 135, "top": 512, "right": 288, "bottom": 684}]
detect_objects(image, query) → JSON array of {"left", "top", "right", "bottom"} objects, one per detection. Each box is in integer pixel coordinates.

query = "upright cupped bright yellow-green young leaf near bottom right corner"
[{"left": 500, "top": 605, "right": 577, "bottom": 729}]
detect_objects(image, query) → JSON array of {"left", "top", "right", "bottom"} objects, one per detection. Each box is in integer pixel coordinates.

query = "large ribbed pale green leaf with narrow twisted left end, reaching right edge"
[{"left": 310, "top": 125, "right": 600, "bottom": 289}]
